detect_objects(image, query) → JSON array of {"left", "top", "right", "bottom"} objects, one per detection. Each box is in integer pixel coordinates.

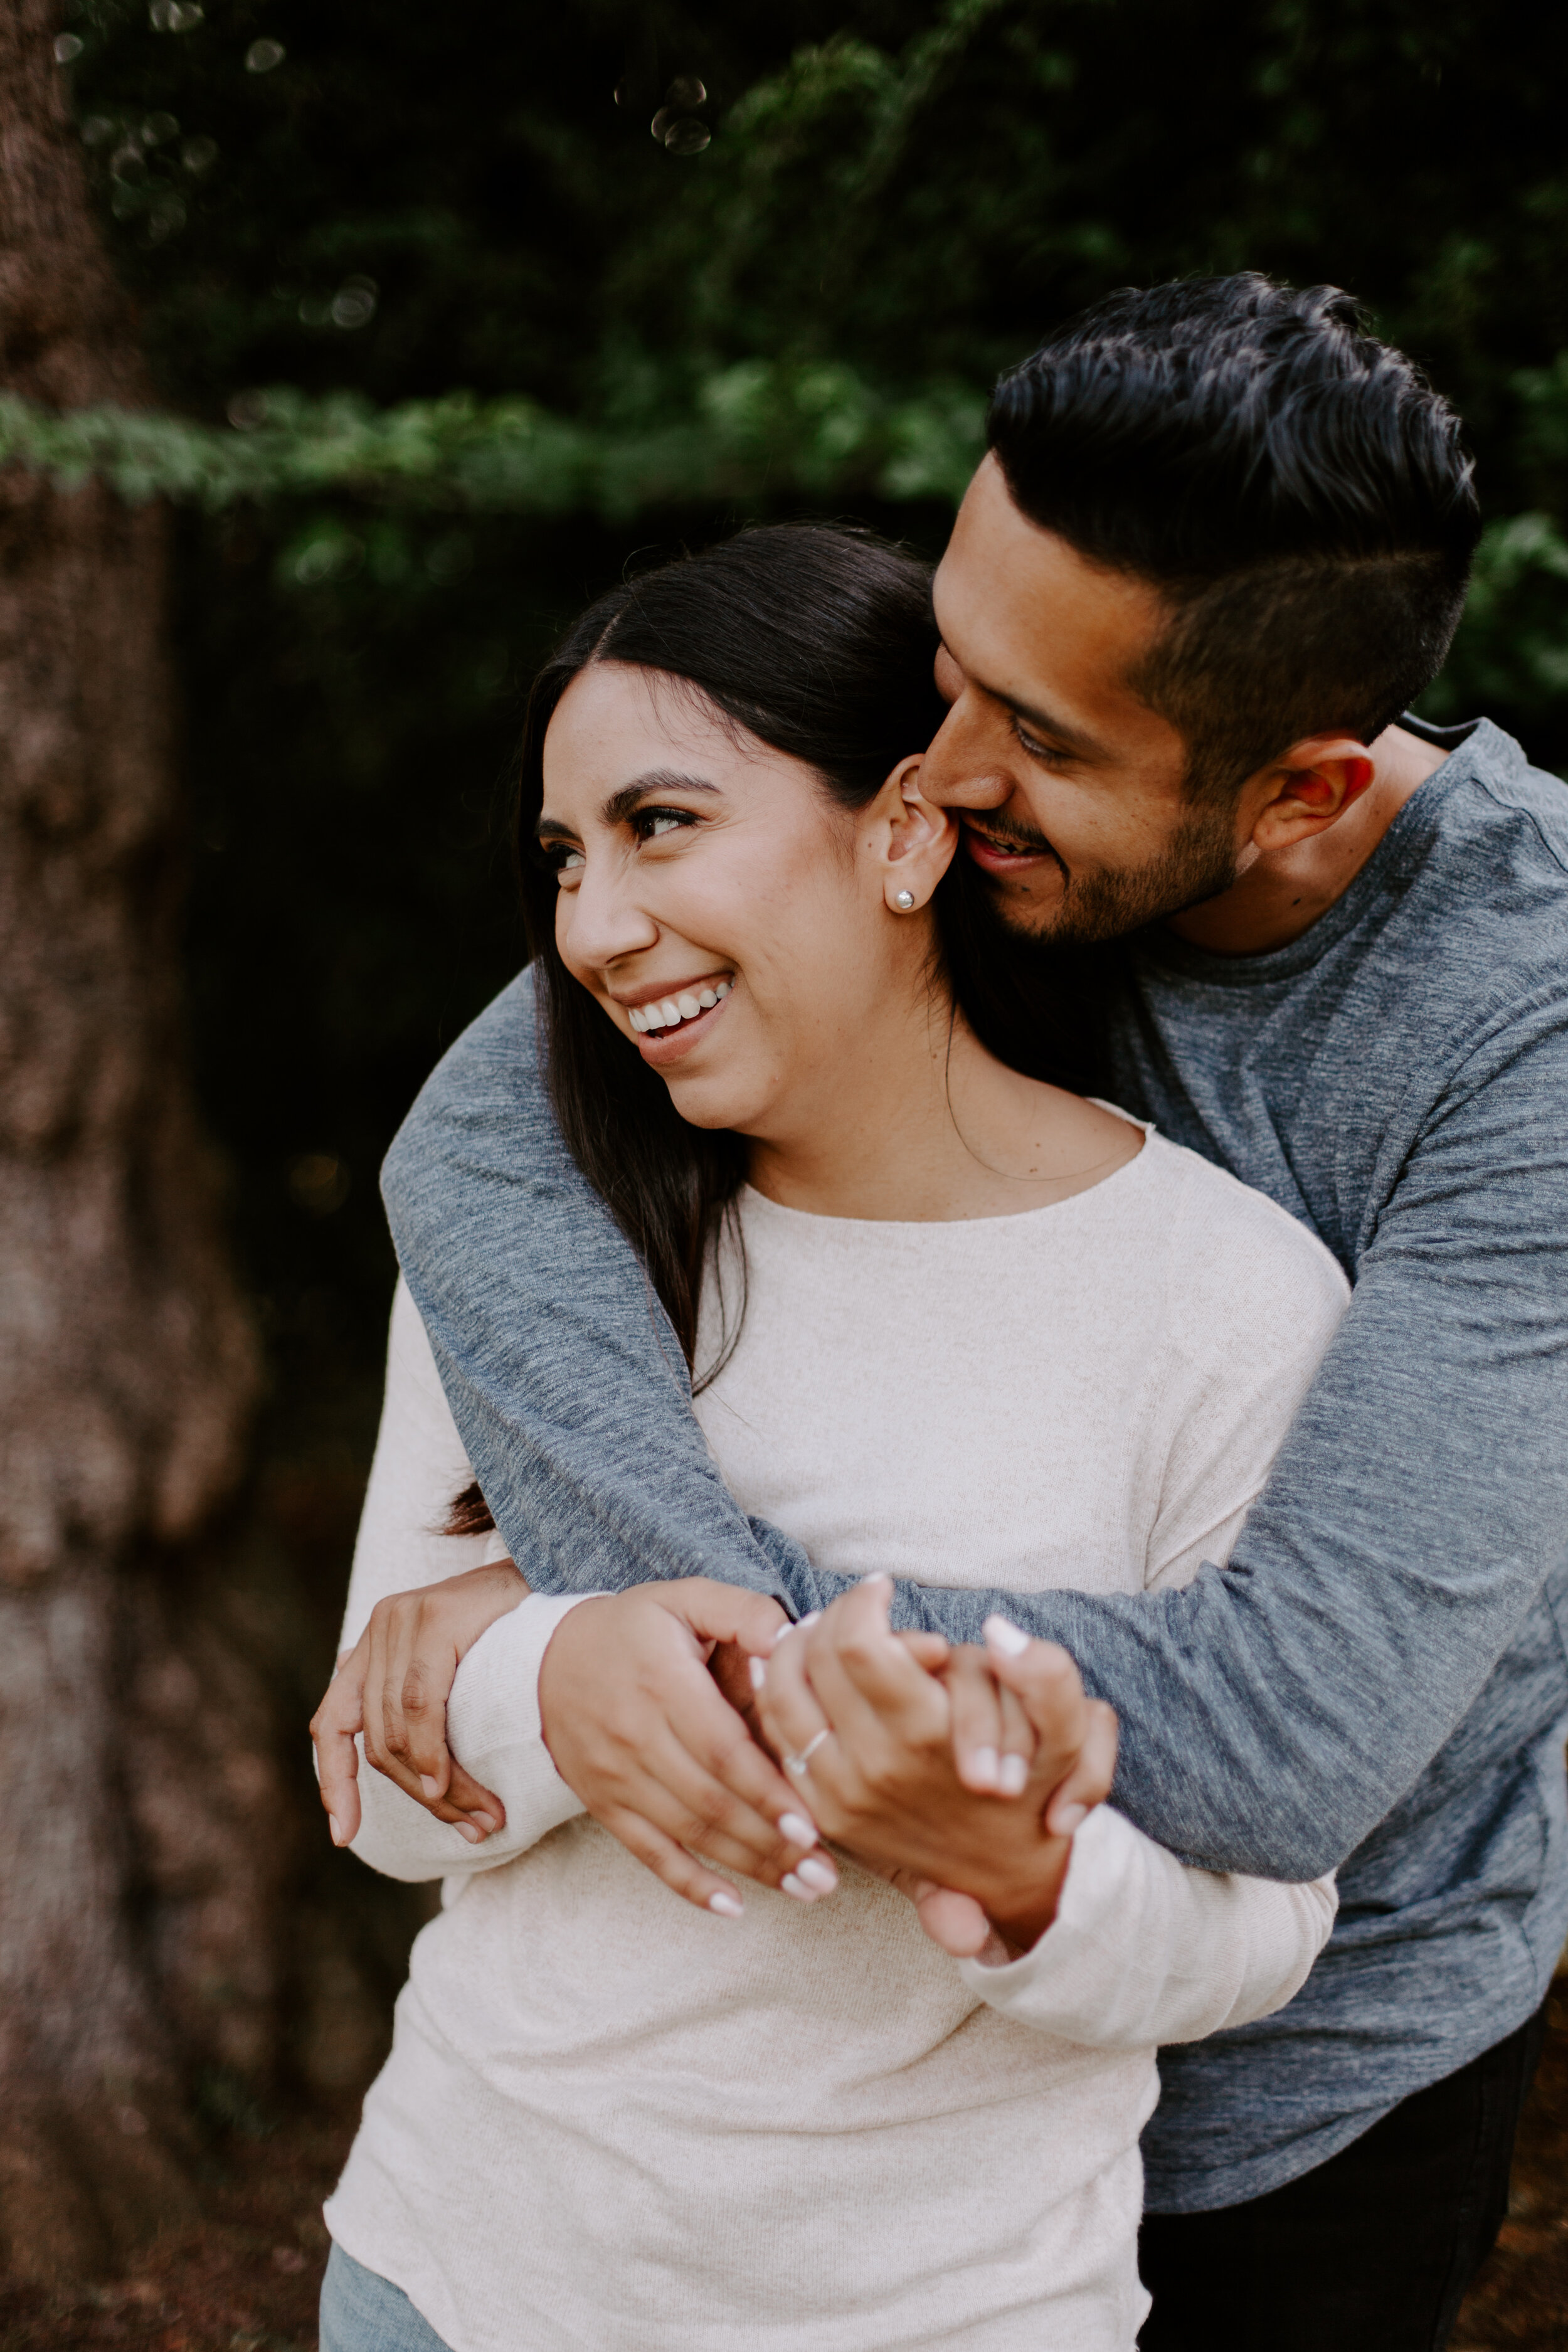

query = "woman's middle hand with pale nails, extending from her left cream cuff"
[{"left": 538, "top": 1576, "right": 837, "bottom": 1919}]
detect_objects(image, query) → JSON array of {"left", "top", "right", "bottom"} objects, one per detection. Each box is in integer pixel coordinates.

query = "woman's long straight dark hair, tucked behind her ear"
[{"left": 515, "top": 522, "right": 1104, "bottom": 1385}]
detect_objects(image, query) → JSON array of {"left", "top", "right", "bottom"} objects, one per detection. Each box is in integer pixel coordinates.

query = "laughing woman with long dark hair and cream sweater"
[{"left": 322, "top": 527, "right": 1345, "bottom": 2352}]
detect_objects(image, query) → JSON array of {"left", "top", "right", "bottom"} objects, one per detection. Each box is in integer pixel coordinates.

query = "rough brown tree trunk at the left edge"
[{"left": 0, "top": 0, "right": 280, "bottom": 2277}]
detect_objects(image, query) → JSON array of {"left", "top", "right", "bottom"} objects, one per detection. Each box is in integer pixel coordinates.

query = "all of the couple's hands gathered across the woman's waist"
[{"left": 310, "top": 1562, "right": 1116, "bottom": 1959}]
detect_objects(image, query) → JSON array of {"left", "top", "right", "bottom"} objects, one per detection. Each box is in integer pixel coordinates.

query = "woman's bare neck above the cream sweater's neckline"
[{"left": 748, "top": 990, "right": 1143, "bottom": 1226}]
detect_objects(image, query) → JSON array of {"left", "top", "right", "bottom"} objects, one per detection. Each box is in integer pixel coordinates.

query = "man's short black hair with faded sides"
[{"left": 987, "top": 273, "right": 1481, "bottom": 797}]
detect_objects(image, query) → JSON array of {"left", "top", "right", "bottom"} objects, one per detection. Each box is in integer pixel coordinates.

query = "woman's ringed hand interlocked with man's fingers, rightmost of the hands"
[{"left": 760, "top": 1578, "right": 1115, "bottom": 1950}]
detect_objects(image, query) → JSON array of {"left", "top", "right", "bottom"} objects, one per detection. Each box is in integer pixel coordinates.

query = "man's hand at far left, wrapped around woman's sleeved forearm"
[{"left": 310, "top": 1559, "right": 529, "bottom": 1846}]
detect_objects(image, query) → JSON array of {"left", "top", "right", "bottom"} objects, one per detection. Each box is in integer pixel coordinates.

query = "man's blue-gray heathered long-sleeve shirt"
[{"left": 383, "top": 720, "right": 1568, "bottom": 2211}]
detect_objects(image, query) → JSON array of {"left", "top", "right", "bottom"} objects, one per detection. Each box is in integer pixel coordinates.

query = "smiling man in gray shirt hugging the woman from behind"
[{"left": 373, "top": 278, "right": 1568, "bottom": 2352}]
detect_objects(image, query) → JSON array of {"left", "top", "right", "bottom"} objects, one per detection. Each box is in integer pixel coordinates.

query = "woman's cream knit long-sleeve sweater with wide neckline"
[{"left": 327, "top": 1136, "right": 1347, "bottom": 2352}]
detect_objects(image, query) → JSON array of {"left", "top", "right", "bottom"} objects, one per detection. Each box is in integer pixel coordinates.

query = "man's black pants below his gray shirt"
[{"left": 1138, "top": 2006, "right": 1547, "bottom": 2352}]
